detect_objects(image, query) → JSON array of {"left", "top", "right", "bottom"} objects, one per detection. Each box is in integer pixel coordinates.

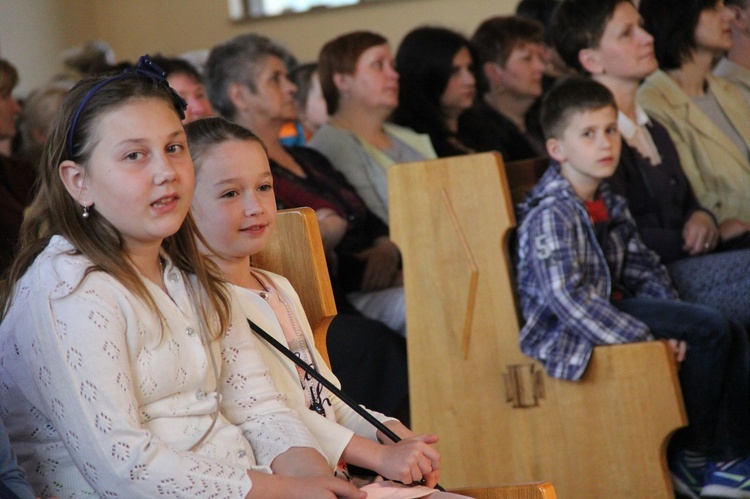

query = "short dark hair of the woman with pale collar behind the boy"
[{"left": 550, "top": 0, "right": 633, "bottom": 74}]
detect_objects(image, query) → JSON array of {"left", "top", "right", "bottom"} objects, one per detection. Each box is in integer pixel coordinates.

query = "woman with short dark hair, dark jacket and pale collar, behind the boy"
[{"left": 553, "top": 0, "right": 750, "bottom": 326}]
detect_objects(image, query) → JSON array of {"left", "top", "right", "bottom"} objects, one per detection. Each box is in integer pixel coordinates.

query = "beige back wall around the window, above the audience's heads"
[{"left": 0, "top": 0, "right": 517, "bottom": 95}]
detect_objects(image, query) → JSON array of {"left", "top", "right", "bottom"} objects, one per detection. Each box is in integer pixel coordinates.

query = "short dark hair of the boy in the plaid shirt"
[{"left": 541, "top": 76, "right": 617, "bottom": 139}]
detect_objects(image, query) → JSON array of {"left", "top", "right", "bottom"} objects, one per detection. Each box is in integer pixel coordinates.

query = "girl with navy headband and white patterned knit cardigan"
[{"left": 0, "top": 57, "right": 364, "bottom": 499}]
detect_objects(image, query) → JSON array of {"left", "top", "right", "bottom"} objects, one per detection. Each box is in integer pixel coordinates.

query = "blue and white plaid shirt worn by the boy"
[{"left": 518, "top": 162, "right": 677, "bottom": 380}]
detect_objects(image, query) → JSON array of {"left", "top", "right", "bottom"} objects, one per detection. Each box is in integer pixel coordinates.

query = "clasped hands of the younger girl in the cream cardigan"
[{"left": 375, "top": 434, "right": 440, "bottom": 487}]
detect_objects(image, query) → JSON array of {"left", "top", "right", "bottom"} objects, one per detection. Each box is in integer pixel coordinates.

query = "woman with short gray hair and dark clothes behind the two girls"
[{"left": 205, "top": 34, "right": 408, "bottom": 420}]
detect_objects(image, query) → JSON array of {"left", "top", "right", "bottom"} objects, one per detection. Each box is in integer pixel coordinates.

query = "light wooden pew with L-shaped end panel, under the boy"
[{"left": 388, "top": 153, "right": 686, "bottom": 499}]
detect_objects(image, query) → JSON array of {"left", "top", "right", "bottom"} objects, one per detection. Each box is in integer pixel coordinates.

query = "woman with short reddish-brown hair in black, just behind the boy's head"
[{"left": 459, "top": 16, "right": 547, "bottom": 161}]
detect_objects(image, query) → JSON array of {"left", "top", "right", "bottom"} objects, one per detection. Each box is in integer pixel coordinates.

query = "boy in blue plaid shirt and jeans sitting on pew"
[{"left": 518, "top": 78, "right": 750, "bottom": 498}]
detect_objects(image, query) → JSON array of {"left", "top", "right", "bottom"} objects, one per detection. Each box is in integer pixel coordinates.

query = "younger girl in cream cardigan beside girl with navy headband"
[{"left": 186, "top": 118, "right": 440, "bottom": 486}]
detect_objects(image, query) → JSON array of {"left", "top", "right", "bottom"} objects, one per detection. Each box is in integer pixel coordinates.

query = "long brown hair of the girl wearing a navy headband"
[{"left": 0, "top": 72, "right": 231, "bottom": 337}]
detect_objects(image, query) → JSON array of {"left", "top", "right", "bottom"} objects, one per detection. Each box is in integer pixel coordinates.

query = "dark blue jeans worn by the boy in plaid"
[{"left": 614, "top": 297, "right": 750, "bottom": 461}]
